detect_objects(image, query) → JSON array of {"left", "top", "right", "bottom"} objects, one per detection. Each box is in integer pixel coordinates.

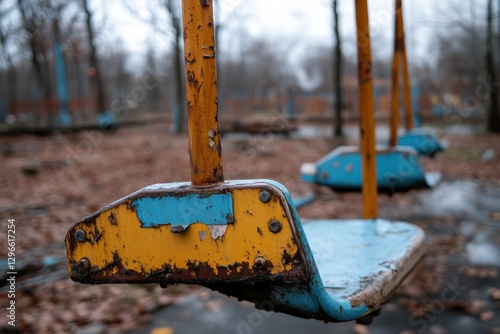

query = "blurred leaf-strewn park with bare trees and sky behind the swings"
[{"left": 0, "top": 0, "right": 500, "bottom": 334}]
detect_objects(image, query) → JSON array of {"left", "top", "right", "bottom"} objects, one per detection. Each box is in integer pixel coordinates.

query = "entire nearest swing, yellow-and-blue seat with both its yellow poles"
[{"left": 66, "top": 0, "right": 424, "bottom": 322}]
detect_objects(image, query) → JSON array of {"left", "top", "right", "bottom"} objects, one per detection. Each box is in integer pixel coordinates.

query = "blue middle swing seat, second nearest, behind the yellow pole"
[{"left": 300, "top": 146, "right": 441, "bottom": 194}]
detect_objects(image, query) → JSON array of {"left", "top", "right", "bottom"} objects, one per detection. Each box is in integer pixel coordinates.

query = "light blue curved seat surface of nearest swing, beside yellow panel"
[{"left": 225, "top": 180, "right": 424, "bottom": 321}]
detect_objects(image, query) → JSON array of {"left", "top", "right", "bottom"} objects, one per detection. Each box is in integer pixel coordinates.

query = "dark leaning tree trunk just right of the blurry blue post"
[{"left": 82, "top": 0, "right": 106, "bottom": 114}]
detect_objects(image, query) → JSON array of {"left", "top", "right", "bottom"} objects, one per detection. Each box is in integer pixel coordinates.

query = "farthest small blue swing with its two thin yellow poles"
[{"left": 389, "top": 0, "right": 448, "bottom": 157}]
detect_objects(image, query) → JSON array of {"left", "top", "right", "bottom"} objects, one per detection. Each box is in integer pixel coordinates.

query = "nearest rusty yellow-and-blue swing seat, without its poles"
[{"left": 66, "top": 180, "right": 423, "bottom": 321}]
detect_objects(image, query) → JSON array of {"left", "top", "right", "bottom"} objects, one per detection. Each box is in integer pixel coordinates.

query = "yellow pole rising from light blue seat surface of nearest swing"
[{"left": 355, "top": 0, "right": 377, "bottom": 219}]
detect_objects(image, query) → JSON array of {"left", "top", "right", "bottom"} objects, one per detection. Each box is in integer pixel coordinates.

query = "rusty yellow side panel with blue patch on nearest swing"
[{"left": 66, "top": 182, "right": 307, "bottom": 284}]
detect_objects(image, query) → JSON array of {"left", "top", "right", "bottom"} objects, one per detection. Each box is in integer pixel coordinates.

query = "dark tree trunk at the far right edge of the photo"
[{"left": 486, "top": 0, "right": 500, "bottom": 133}]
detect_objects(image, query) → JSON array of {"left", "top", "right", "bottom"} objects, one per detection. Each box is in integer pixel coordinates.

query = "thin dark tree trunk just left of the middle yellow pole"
[{"left": 333, "top": 0, "right": 343, "bottom": 137}]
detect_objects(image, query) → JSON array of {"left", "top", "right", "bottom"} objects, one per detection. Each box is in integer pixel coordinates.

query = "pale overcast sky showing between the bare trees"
[{"left": 95, "top": 0, "right": 486, "bottom": 69}]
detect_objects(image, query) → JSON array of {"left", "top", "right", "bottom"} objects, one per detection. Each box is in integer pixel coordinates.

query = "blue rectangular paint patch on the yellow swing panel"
[{"left": 132, "top": 193, "right": 234, "bottom": 228}]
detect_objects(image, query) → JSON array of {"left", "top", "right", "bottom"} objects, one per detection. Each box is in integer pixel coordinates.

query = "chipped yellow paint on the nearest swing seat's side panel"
[{"left": 66, "top": 188, "right": 300, "bottom": 279}]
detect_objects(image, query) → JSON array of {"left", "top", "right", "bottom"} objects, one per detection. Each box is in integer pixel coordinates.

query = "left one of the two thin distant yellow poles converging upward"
[{"left": 389, "top": 0, "right": 403, "bottom": 147}]
